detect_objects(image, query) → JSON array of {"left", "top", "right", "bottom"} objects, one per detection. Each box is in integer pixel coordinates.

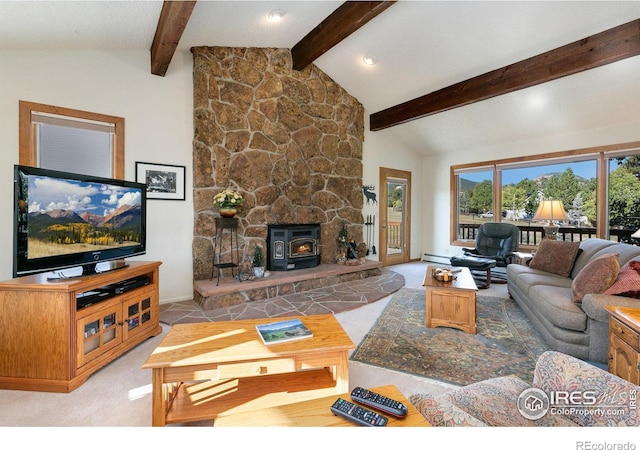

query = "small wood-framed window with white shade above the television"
[{"left": 19, "top": 101, "right": 124, "bottom": 179}]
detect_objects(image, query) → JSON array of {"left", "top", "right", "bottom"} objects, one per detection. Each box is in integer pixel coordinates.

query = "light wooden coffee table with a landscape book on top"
[{"left": 142, "top": 314, "right": 355, "bottom": 426}]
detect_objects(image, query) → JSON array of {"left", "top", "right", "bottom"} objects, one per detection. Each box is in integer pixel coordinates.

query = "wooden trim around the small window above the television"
[{"left": 18, "top": 100, "right": 124, "bottom": 180}]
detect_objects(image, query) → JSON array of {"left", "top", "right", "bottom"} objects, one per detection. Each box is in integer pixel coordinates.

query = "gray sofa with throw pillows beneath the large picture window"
[{"left": 507, "top": 238, "right": 640, "bottom": 363}]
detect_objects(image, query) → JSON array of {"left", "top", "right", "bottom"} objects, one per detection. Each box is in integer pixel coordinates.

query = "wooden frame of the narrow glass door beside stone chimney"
[{"left": 378, "top": 167, "right": 411, "bottom": 266}]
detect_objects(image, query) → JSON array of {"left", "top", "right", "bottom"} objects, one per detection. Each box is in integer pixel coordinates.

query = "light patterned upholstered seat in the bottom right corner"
[{"left": 409, "top": 351, "right": 640, "bottom": 427}]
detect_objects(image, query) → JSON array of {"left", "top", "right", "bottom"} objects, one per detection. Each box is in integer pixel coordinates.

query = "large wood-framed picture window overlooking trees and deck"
[{"left": 451, "top": 142, "right": 640, "bottom": 247}]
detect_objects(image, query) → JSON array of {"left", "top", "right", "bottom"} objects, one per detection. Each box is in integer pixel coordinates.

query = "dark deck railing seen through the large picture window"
[{"left": 458, "top": 223, "right": 637, "bottom": 246}]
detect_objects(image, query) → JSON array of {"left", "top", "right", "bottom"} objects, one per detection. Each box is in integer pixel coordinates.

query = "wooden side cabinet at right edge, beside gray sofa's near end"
[{"left": 605, "top": 306, "right": 640, "bottom": 384}]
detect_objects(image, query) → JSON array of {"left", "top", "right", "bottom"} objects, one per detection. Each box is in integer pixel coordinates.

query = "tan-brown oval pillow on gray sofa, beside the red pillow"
[{"left": 571, "top": 253, "right": 620, "bottom": 303}]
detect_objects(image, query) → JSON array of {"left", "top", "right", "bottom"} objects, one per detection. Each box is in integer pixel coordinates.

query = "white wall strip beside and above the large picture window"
[{"left": 422, "top": 123, "right": 640, "bottom": 257}]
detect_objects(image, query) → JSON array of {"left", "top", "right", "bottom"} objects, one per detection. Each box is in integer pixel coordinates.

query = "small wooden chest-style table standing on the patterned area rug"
[{"left": 422, "top": 265, "right": 478, "bottom": 334}]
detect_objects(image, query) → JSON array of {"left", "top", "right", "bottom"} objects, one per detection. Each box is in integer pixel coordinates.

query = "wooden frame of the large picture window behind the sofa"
[{"left": 449, "top": 141, "right": 640, "bottom": 246}]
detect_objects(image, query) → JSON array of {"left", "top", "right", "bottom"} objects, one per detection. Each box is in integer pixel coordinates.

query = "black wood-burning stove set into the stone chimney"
[{"left": 267, "top": 224, "right": 320, "bottom": 270}]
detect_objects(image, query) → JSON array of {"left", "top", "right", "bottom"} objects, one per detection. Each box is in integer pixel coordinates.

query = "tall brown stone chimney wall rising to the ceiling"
[{"left": 191, "top": 47, "right": 364, "bottom": 281}]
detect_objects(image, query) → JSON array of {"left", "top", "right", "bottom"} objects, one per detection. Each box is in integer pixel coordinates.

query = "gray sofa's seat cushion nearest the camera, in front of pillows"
[{"left": 529, "top": 285, "right": 588, "bottom": 332}]
